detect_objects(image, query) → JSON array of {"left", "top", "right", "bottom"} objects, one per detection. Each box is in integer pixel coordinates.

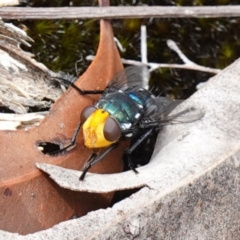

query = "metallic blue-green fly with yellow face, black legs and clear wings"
[{"left": 40, "top": 66, "right": 202, "bottom": 180}]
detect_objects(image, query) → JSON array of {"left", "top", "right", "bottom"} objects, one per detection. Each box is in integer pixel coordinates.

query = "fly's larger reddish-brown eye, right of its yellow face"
[{"left": 103, "top": 117, "right": 121, "bottom": 142}]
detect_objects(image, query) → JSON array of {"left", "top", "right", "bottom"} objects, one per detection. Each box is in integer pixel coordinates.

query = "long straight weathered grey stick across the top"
[{"left": 0, "top": 5, "right": 240, "bottom": 20}]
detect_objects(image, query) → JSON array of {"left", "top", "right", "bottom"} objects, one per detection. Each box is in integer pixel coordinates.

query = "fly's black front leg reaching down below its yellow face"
[{"left": 79, "top": 143, "right": 118, "bottom": 181}]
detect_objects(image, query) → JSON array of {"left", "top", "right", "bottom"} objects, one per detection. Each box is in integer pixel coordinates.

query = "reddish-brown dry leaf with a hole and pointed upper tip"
[{"left": 0, "top": 14, "right": 124, "bottom": 234}]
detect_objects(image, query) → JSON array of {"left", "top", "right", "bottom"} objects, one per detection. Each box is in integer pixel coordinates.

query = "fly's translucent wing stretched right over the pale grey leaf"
[{"left": 140, "top": 97, "right": 205, "bottom": 128}]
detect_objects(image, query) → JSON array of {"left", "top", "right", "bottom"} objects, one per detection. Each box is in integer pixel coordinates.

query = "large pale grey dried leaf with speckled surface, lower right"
[{"left": 4, "top": 44, "right": 240, "bottom": 240}]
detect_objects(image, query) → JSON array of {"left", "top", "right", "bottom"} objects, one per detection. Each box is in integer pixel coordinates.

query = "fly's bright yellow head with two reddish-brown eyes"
[{"left": 81, "top": 106, "right": 121, "bottom": 148}]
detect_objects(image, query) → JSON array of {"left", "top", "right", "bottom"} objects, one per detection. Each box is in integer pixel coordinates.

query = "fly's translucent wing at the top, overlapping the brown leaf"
[{"left": 104, "top": 66, "right": 149, "bottom": 93}]
